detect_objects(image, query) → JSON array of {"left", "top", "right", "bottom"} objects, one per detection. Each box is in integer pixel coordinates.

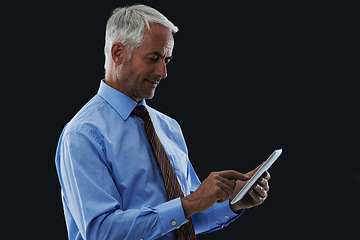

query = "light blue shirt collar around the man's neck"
[{"left": 98, "top": 79, "right": 147, "bottom": 121}]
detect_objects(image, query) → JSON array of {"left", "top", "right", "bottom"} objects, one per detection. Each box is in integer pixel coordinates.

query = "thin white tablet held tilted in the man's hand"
[{"left": 231, "top": 149, "right": 282, "bottom": 204}]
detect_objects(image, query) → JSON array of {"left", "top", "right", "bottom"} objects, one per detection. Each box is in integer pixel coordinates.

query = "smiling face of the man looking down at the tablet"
[{"left": 117, "top": 24, "right": 174, "bottom": 102}]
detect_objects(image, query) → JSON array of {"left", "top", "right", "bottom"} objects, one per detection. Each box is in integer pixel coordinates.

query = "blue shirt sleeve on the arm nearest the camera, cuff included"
[{"left": 56, "top": 130, "right": 188, "bottom": 239}]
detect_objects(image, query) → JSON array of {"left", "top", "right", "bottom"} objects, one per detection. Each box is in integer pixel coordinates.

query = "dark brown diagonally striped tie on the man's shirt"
[{"left": 133, "top": 105, "right": 196, "bottom": 240}]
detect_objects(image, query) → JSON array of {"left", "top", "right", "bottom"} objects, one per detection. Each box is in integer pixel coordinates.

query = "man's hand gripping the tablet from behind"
[{"left": 230, "top": 163, "right": 270, "bottom": 212}]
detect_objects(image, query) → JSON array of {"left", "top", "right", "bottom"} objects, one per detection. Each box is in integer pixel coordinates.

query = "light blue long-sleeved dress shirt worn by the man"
[{"left": 55, "top": 80, "right": 242, "bottom": 240}]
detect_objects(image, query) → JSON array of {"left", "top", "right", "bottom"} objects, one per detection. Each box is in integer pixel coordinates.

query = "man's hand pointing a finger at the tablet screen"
[{"left": 181, "top": 170, "right": 250, "bottom": 218}]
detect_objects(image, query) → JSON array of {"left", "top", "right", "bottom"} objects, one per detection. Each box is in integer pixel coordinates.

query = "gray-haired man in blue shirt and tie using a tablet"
[{"left": 56, "top": 5, "right": 270, "bottom": 239}]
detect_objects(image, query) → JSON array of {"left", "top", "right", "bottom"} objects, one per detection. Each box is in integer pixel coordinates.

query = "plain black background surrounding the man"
[{"left": 1, "top": 1, "right": 360, "bottom": 239}]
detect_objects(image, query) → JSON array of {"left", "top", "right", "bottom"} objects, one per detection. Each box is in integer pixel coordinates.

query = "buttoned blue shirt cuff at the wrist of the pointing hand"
[{"left": 156, "top": 198, "right": 189, "bottom": 233}]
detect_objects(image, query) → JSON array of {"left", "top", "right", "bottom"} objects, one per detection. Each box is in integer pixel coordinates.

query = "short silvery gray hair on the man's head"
[{"left": 104, "top": 5, "right": 178, "bottom": 74}]
